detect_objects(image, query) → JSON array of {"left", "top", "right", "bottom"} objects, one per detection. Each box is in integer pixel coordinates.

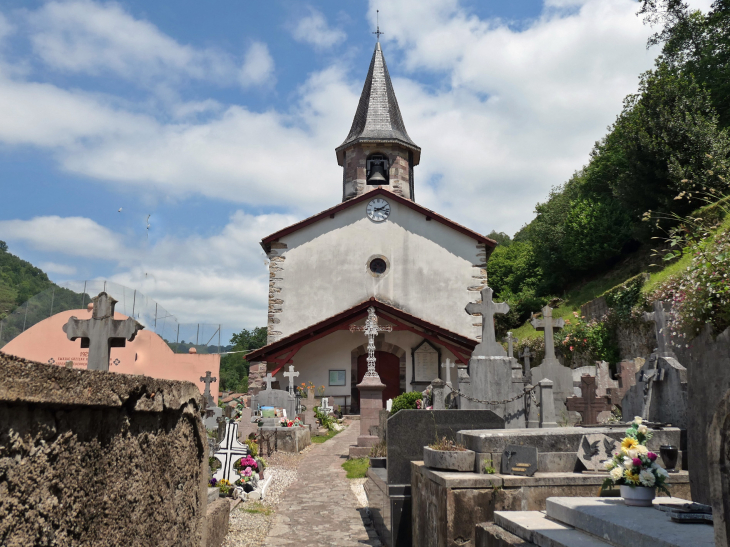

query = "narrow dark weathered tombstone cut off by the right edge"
[{"left": 707, "top": 391, "right": 730, "bottom": 545}]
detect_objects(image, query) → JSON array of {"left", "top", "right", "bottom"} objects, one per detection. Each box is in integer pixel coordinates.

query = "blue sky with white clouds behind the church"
[{"left": 0, "top": 0, "right": 709, "bottom": 340}]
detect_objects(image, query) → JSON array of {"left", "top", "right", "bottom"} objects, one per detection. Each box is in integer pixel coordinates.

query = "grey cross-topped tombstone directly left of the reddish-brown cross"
[{"left": 527, "top": 306, "right": 573, "bottom": 427}]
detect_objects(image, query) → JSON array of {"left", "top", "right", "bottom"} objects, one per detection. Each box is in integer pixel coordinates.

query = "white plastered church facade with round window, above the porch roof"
[{"left": 269, "top": 201, "right": 486, "bottom": 341}]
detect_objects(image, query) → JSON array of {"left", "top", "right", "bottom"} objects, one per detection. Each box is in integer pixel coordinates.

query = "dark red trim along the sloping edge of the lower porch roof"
[{"left": 245, "top": 298, "right": 478, "bottom": 362}]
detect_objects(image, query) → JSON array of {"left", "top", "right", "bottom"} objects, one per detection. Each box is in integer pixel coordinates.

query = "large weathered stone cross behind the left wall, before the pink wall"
[{"left": 63, "top": 292, "right": 144, "bottom": 370}]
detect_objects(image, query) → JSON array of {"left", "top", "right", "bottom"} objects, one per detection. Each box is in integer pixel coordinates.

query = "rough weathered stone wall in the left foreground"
[{"left": 0, "top": 353, "right": 208, "bottom": 547}]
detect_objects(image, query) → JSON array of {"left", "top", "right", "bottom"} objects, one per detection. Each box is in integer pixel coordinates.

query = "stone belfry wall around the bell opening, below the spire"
[{"left": 342, "top": 143, "right": 412, "bottom": 201}]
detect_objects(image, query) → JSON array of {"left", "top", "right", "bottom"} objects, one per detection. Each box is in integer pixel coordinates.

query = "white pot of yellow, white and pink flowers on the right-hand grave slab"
[{"left": 601, "top": 416, "right": 670, "bottom": 507}]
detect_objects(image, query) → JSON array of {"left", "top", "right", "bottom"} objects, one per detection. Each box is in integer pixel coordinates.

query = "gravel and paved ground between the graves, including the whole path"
[{"left": 223, "top": 421, "right": 380, "bottom": 547}]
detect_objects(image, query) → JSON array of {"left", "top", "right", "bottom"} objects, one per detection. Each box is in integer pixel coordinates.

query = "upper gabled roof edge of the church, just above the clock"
[{"left": 261, "top": 186, "right": 497, "bottom": 250}]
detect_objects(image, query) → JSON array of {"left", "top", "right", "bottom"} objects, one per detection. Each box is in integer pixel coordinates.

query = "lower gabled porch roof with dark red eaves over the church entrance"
[{"left": 244, "top": 297, "right": 478, "bottom": 376}]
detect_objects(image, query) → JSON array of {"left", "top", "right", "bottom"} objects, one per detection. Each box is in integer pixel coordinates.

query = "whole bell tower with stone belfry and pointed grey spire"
[{"left": 335, "top": 41, "right": 421, "bottom": 201}]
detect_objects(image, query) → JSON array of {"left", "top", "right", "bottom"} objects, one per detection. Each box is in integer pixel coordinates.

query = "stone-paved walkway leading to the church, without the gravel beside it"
[{"left": 264, "top": 421, "right": 380, "bottom": 547}]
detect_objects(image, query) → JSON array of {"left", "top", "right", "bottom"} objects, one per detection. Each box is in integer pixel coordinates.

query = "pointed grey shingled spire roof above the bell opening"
[{"left": 335, "top": 42, "right": 421, "bottom": 165}]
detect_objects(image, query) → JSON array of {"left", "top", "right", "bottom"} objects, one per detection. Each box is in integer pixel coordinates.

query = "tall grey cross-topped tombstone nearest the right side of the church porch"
[{"left": 459, "top": 287, "right": 526, "bottom": 429}]
